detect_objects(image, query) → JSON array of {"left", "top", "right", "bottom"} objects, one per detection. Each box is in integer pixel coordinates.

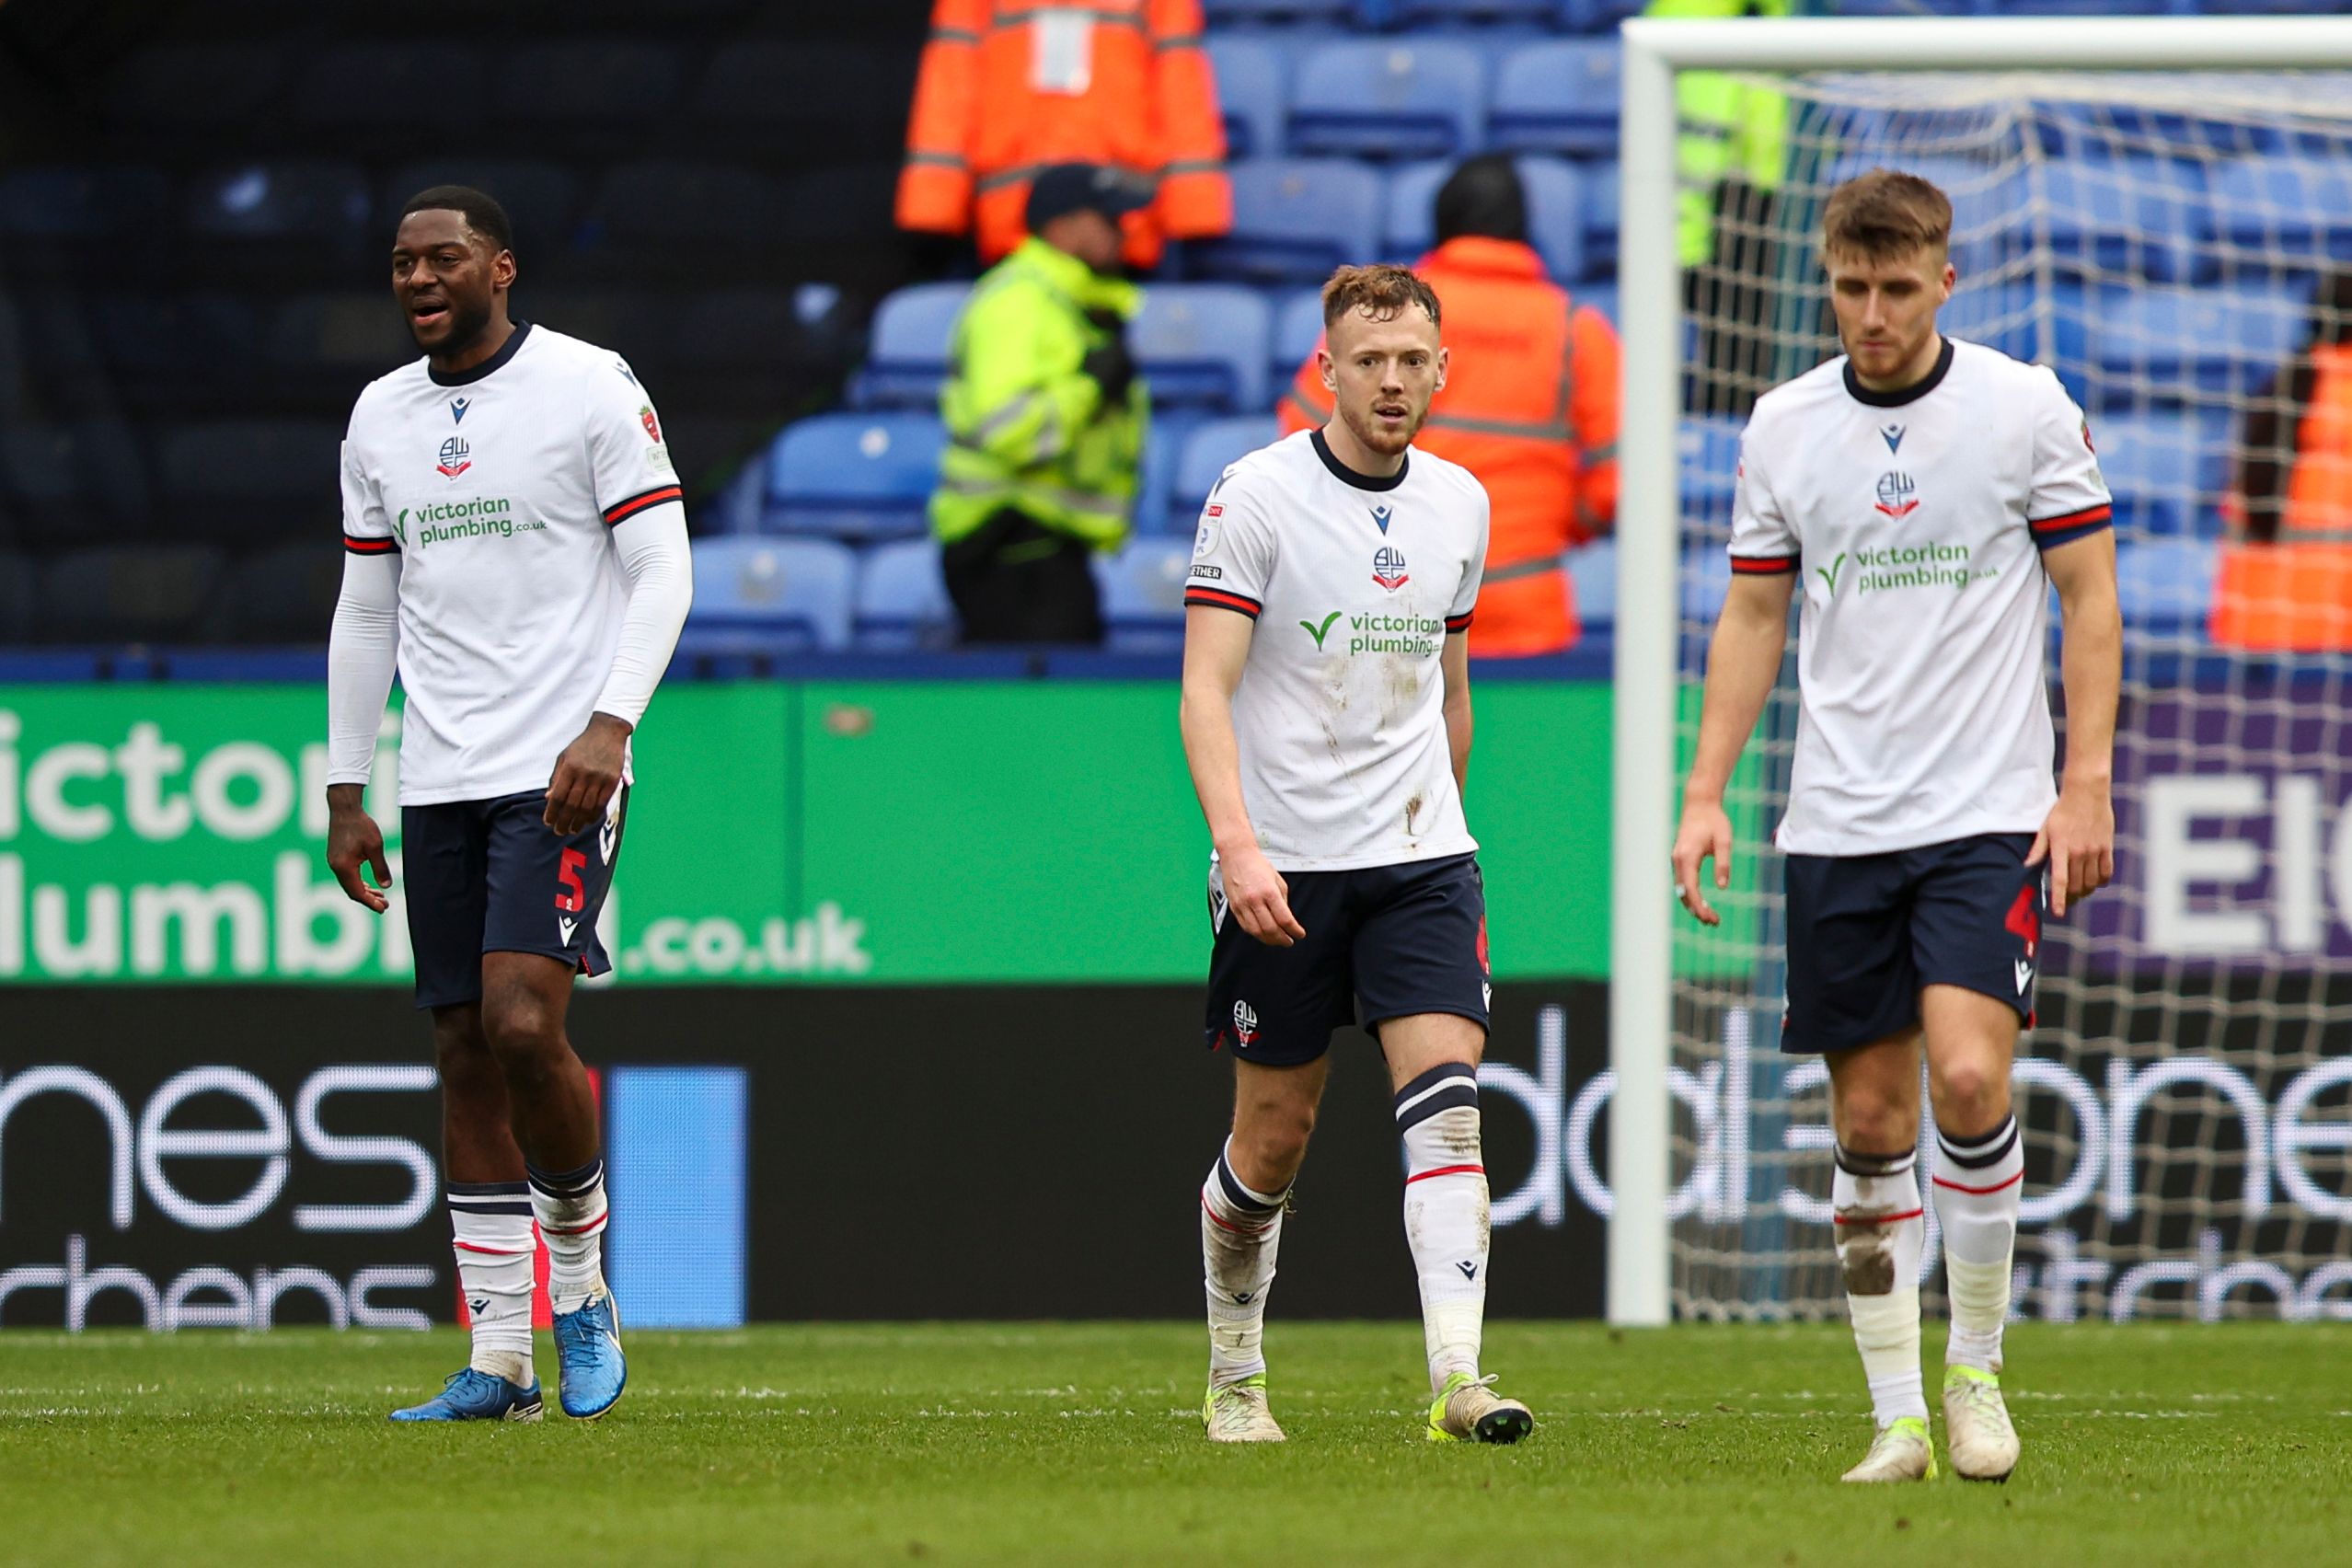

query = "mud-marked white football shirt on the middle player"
[{"left": 1185, "top": 431, "right": 1486, "bottom": 872}]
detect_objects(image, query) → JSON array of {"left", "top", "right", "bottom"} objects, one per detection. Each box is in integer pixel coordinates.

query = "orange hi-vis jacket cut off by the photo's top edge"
[{"left": 898, "top": 0, "right": 1232, "bottom": 266}]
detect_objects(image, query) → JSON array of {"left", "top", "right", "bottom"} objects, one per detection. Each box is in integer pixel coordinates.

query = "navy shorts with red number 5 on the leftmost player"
[{"left": 400, "top": 785, "right": 628, "bottom": 1006}]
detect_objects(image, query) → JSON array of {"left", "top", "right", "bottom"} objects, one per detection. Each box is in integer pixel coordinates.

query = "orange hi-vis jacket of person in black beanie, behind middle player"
[{"left": 1282, "top": 235, "right": 1619, "bottom": 656}]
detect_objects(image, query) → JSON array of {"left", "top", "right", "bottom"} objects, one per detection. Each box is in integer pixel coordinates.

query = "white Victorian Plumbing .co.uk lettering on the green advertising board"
[{"left": 0, "top": 708, "right": 872, "bottom": 980}]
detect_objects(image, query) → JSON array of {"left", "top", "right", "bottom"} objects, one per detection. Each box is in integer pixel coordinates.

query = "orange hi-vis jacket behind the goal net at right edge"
[{"left": 2211, "top": 343, "right": 2352, "bottom": 653}]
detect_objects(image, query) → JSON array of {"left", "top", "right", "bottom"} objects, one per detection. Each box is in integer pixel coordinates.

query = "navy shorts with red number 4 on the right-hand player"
[{"left": 1781, "top": 832, "right": 2048, "bottom": 1054}]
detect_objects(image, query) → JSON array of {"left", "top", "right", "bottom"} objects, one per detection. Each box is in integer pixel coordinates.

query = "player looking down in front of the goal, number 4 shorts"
[{"left": 1675, "top": 169, "right": 2122, "bottom": 1481}]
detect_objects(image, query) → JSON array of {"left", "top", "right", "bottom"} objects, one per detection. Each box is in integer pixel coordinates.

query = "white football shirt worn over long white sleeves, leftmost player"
[{"left": 343, "top": 325, "right": 682, "bottom": 806}]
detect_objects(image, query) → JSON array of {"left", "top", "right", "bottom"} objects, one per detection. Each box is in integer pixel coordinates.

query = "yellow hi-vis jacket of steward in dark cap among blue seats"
[{"left": 931, "top": 237, "right": 1150, "bottom": 550}]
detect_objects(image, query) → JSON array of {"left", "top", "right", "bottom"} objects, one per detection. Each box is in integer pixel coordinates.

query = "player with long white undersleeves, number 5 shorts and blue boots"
[{"left": 327, "top": 186, "right": 694, "bottom": 1423}]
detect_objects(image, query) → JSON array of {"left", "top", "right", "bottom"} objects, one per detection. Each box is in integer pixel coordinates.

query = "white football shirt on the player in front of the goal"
[{"left": 1731, "top": 339, "right": 2110, "bottom": 856}]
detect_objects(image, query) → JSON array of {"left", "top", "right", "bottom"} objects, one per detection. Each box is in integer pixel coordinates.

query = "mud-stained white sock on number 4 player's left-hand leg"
[{"left": 1830, "top": 1145, "right": 1926, "bottom": 1427}]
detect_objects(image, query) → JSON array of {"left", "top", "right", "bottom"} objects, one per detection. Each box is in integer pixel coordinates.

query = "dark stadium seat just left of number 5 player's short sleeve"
[{"left": 156, "top": 419, "right": 343, "bottom": 543}]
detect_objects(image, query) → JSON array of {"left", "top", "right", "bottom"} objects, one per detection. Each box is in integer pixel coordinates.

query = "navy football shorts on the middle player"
[{"left": 1205, "top": 856, "right": 1492, "bottom": 1067}]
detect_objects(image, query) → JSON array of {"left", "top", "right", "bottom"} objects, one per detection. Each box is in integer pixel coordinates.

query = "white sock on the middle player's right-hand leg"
[{"left": 1397, "top": 1063, "right": 1489, "bottom": 1394}]
